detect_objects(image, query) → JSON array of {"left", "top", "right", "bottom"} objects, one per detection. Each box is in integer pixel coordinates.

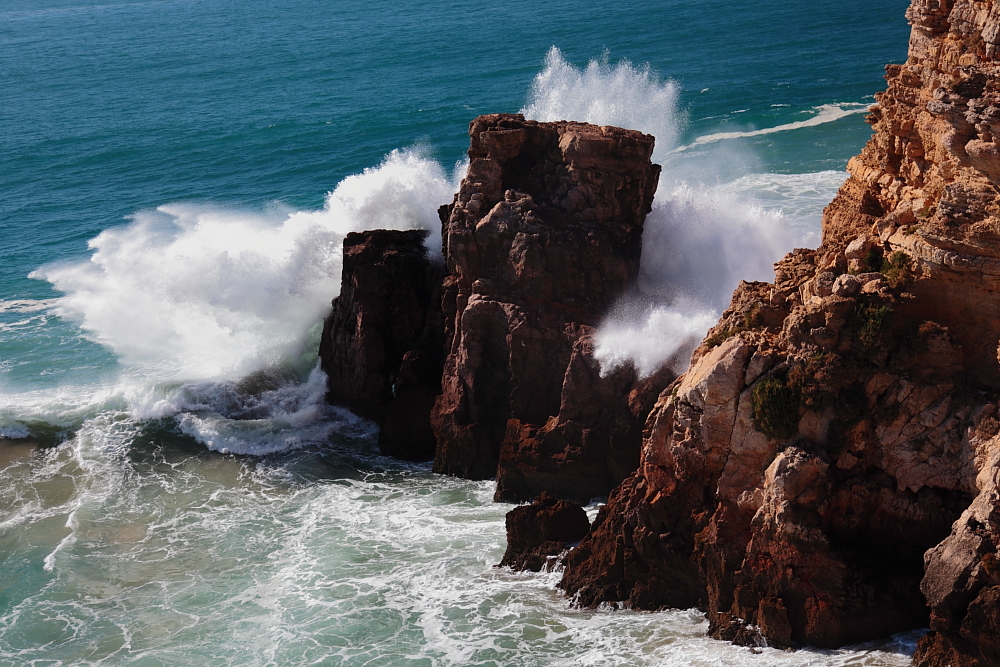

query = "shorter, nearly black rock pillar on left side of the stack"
[{"left": 320, "top": 230, "right": 444, "bottom": 461}]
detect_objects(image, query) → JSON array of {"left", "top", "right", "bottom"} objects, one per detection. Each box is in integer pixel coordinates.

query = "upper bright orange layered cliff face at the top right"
[{"left": 821, "top": 0, "right": 1000, "bottom": 386}]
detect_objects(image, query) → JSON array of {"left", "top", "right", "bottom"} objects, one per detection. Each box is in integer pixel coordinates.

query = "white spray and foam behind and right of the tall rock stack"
[{"left": 522, "top": 47, "right": 844, "bottom": 374}]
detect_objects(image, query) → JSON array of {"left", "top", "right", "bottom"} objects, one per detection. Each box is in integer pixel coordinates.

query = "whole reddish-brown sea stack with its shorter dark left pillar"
[{"left": 320, "top": 114, "right": 674, "bottom": 502}]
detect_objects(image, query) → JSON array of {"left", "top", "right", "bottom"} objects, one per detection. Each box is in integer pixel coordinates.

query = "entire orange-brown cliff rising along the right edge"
[{"left": 562, "top": 0, "right": 1000, "bottom": 656}]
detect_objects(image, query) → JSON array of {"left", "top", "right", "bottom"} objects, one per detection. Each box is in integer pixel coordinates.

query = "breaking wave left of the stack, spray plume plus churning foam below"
[{"left": 10, "top": 149, "right": 457, "bottom": 455}]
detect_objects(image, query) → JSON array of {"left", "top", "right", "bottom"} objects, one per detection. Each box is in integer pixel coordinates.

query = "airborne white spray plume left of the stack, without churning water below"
[{"left": 31, "top": 150, "right": 455, "bottom": 380}]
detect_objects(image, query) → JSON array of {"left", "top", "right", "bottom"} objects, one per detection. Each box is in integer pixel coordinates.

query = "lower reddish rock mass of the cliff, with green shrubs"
[{"left": 561, "top": 272, "right": 978, "bottom": 647}]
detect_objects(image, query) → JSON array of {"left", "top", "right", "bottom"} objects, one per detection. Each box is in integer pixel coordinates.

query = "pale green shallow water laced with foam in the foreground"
[{"left": 0, "top": 434, "right": 915, "bottom": 665}]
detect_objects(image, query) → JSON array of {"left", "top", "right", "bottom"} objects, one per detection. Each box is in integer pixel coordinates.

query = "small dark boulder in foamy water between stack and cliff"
[{"left": 497, "top": 492, "right": 590, "bottom": 572}]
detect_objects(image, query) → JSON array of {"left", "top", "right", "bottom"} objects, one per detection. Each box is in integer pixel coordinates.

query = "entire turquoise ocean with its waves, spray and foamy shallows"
[{"left": 0, "top": 0, "right": 919, "bottom": 667}]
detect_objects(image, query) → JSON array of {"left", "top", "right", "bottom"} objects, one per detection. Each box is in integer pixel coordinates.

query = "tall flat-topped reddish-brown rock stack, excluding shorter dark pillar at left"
[{"left": 432, "top": 114, "right": 672, "bottom": 501}]
